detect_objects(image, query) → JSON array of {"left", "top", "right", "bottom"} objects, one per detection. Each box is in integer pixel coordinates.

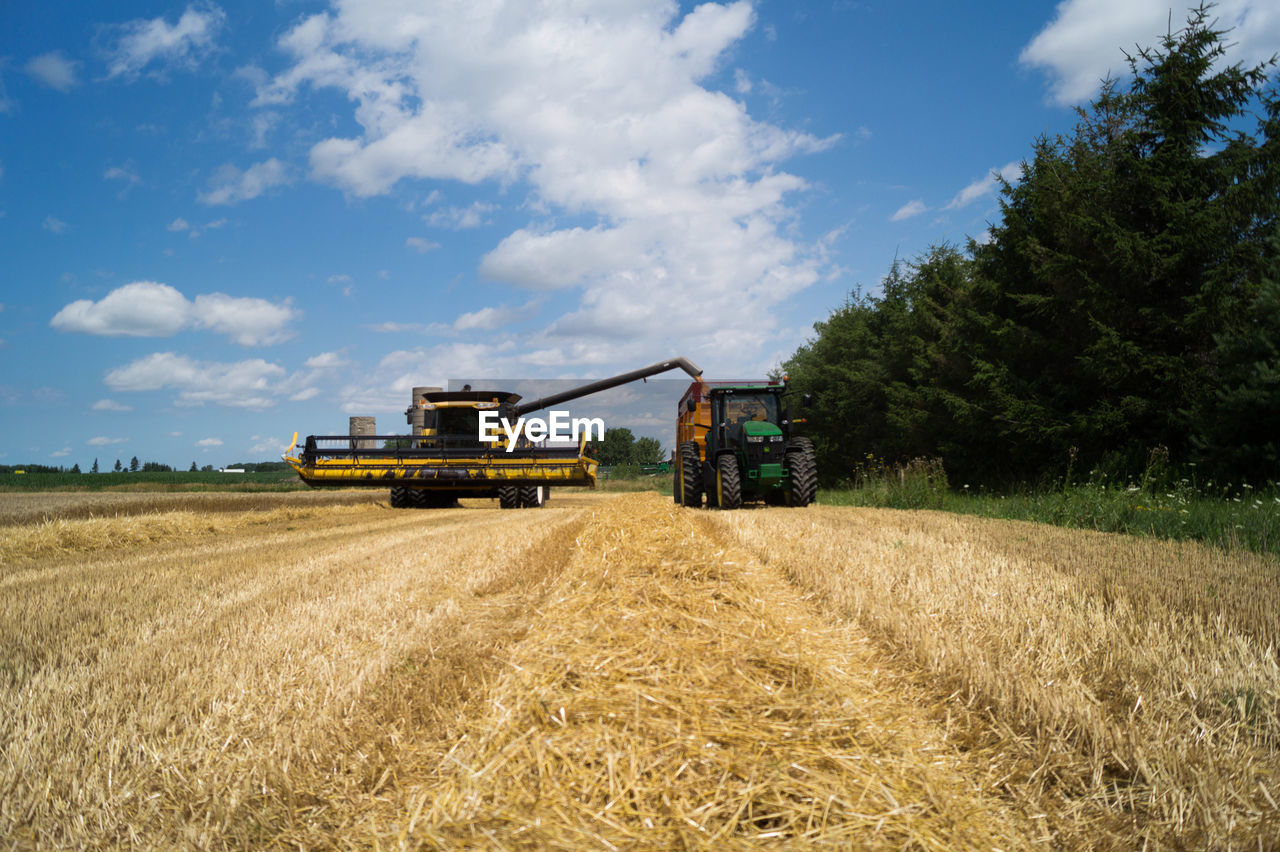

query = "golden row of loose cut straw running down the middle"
[{"left": 401, "top": 494, "right": 1039, "bottom": 849}]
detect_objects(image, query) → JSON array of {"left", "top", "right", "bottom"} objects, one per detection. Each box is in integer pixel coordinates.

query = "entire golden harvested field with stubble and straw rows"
[{"left": 0, "top": 491, "right": 1280, "bottom": 849}]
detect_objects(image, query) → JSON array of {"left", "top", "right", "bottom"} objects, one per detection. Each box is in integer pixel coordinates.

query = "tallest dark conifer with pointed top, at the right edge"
[{"left": 972, "top": 6, "right": 1280, "bottom": 476}]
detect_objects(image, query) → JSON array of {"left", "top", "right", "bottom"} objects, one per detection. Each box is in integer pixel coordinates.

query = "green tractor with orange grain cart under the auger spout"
[{"left": 672, "top": 380, "right": 818, "bottom": 509}]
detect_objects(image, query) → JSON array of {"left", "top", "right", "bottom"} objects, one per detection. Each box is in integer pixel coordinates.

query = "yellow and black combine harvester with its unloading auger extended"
[{"left": 283, "top": 358, "right": 703, "bottom": 509}]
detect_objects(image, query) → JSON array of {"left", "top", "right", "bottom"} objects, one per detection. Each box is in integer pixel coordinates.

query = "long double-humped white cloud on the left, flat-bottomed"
[{"left": 49, "top": 281, "right": 297, "bottom": 345}]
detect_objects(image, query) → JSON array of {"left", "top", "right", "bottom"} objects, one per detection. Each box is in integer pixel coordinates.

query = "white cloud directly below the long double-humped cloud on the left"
[{"left": 104, "top": 352, "right": 285, "bottom": 408}]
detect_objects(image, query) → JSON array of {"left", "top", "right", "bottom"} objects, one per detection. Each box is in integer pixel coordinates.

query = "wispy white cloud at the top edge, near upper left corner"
[{"left": 106, "top": 4, "right": 227, "bottom": 79}]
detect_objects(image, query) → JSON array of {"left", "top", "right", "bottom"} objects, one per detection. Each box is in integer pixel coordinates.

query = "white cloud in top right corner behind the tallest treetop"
[{"left": 1019, "top": 0, "right": 1280, "bottom": 105}]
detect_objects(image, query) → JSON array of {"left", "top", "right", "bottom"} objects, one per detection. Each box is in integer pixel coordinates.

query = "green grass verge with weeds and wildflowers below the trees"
[{"left": 818, "top": 450, "right": 1280, "bottom": 554}]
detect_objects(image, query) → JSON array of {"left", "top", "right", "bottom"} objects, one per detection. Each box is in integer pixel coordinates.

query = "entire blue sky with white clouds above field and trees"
[{"left": 0, "top": 0, "right": 1280, "bottom": 471}]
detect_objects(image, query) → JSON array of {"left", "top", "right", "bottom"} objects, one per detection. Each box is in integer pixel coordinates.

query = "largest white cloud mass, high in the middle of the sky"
[{"left": 256, "top": 0, "right": 835, "bottom": 370}]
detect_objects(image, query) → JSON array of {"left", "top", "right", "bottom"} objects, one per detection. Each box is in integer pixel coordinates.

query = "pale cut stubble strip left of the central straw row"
[{"left": 0, "top": 499, "right": 589, "bottom": 848}]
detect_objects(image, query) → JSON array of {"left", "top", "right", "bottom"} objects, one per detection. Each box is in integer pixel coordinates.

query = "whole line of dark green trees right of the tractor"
[{"left": 783, "top": 6, "right": 1280, "bottom": 486}]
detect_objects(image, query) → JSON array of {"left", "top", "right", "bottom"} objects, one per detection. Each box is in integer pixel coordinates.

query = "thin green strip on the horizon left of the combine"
[{"left": 0, "top": 471, "right": 307, "bottom": 493}]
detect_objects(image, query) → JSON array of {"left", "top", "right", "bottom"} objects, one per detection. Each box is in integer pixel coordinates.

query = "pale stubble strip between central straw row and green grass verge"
[{"left": 713, "top": 508, "right": 1280, "bottom": 848}]
